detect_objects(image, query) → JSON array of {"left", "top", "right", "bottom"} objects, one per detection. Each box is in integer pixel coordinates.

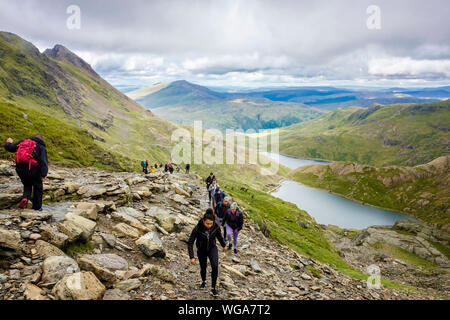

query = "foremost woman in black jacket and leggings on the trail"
[{"left": 188, "top": 209, "right": 227, "bottom": 296}]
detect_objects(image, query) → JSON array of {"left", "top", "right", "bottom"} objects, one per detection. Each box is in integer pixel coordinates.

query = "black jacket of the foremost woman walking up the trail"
[{"left": 188, "top": 219, "right": 226, "bottom": 259}]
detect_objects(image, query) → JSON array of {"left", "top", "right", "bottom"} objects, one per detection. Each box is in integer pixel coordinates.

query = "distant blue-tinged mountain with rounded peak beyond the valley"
[{"left": 128, "top": 80, "right": 324, "bottom": 130}]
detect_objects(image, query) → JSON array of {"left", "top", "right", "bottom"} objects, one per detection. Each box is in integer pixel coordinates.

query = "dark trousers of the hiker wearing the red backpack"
[{"left": 16, "top": 165, "right": 44, "bottom": 210}]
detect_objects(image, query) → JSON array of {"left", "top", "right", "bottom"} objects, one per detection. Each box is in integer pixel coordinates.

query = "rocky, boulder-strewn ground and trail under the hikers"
[{"left": 0, "top": 161, "right": 442, "bottom": 300}]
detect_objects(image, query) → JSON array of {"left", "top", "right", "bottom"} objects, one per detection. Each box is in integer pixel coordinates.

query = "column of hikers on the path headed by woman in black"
[{"left": 188, "top": 172, "right": 244, "bottom": 296}]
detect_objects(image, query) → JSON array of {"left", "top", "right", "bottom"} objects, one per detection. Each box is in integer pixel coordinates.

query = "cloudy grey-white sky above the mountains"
[{"left": 0, "top": 0, "right": 450, "bottom": 87}]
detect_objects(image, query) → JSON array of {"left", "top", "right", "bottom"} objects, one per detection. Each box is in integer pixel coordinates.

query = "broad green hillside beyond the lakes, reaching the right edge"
[{"left": 280, "top": 100, "right": 450, "bottom": 166}]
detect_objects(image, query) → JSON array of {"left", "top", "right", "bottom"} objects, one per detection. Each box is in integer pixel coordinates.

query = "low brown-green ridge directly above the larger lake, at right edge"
[{"left": 290, "top": 156, "right": 450, "bottom": 228}]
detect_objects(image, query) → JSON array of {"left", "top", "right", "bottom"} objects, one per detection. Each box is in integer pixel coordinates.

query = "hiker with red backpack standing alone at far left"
[{"left": 4, "top": 134, "right": 48, "bottom": 210}]
